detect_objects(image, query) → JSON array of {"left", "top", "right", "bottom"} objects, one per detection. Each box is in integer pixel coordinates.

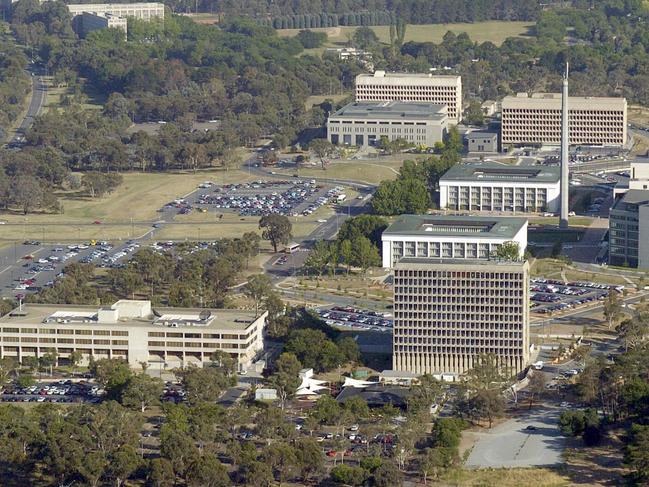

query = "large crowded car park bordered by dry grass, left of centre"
[{"left": 160, "top": 179, "right": 346, "bottom": 216}]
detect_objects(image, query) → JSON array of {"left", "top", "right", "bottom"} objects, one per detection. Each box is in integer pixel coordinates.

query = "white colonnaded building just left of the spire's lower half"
[{"left": 439, "top": 163, "right": 561, "bottom": 212}]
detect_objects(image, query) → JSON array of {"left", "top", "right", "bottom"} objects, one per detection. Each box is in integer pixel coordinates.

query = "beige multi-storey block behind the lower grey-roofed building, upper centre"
[{"left": 356, "top": 71, "right": 462, "bottom": 125}]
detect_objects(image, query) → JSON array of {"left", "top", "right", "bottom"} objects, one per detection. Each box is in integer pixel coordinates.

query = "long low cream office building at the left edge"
[{"left": 0, "top": 300, "right": 268, "bottom": 370}]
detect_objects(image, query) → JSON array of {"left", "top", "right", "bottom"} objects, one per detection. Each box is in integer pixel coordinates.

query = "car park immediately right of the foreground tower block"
[{"left": 530, "top": 277, "right": 624, "bottom": 314}]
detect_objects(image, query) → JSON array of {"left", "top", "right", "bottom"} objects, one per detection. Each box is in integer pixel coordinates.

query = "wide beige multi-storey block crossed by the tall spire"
[{"left": 501, "top": 93, "right": 627, "bottom": 147}]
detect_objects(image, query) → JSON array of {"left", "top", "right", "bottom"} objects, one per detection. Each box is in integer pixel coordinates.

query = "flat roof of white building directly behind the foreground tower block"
[{"left": 383, "top": 215, "right": 527, "bottom": 240}]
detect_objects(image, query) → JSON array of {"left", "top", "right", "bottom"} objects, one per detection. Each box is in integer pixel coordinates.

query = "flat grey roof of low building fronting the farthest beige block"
[{"left": 329, "top": 101, "right": 448, "bottom": 120}]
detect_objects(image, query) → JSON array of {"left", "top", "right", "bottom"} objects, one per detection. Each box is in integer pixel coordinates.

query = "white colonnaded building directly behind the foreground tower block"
[{"left": 381, "top": 215, "right": 527, "bottom": 269}]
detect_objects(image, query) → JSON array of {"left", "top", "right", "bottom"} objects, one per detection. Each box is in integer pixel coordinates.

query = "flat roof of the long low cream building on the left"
[{"left": 0, "top": 303, "right": 258, "bottom": 331}]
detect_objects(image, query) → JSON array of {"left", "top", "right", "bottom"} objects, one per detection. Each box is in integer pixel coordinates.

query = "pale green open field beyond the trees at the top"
[{"left": 277, "top": 21, "right": 534, "bottom": 50}]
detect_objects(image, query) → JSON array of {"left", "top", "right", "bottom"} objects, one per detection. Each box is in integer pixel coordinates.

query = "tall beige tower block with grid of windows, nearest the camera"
[{"left": 392, "top": 258, "right": 530, "bottom": 376}]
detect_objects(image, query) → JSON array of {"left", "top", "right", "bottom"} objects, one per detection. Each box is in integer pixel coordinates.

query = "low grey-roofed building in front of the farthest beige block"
[{"left": 327, "top": 101, "right": 448, "bottom": 147}]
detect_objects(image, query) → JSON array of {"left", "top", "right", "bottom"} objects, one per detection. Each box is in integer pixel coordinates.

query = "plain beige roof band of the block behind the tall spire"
[{"left": 502, "top": 93, "right": 626, "bottom": 110}]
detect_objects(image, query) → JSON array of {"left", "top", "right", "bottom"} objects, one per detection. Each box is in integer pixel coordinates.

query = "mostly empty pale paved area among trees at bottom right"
[{"left": 466, "top": 408, "right": 566, "bottom": 468}]
